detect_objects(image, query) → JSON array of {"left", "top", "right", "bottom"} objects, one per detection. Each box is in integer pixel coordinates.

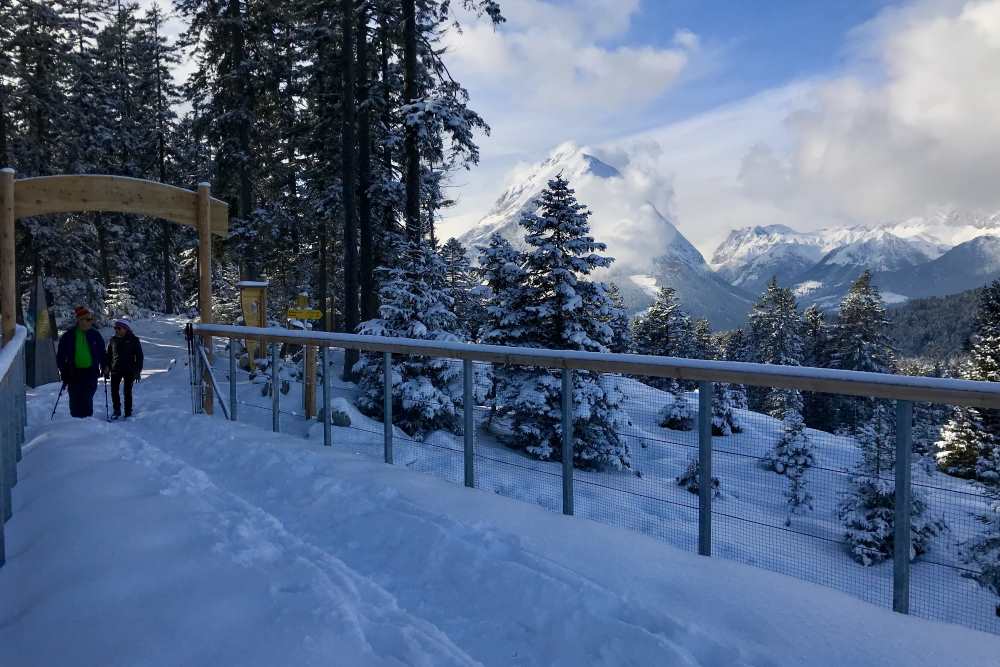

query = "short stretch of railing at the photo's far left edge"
[{"left": 0, "top": 326, "right": 27, "bottom": 567}]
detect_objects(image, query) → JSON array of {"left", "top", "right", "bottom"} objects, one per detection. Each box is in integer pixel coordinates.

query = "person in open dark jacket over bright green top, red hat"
[{"left": 56, "top": 306, "right": 107, "bottom": 418}]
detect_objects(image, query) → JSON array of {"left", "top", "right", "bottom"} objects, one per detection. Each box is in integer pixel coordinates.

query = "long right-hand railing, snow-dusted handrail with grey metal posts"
[{"left": 192, "top": 324, "right": 1000, "bottom": 628}]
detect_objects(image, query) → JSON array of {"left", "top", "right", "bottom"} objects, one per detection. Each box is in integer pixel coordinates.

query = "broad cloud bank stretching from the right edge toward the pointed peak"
[{"left": 450, "top": 0, "right": 1000, "bottom": 255}]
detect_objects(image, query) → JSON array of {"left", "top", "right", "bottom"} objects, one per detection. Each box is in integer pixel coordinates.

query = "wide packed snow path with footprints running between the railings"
[{"left": 0, "top": 322, "right": 1000, "bottom": 666}]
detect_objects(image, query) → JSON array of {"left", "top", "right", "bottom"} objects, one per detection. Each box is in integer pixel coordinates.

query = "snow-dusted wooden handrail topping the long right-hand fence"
[{"left": 194, "top": 324, "right": 1000, "bottom": 409}]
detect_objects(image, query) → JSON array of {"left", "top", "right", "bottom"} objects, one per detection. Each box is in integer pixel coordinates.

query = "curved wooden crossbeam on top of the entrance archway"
[{"left": 14, "top": 175, "right": 229, "bottom": 236}]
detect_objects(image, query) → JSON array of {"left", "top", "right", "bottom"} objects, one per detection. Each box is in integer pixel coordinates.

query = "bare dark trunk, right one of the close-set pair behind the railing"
[{"left": 357, "top": 3, "right": 378, "bottom": 321}]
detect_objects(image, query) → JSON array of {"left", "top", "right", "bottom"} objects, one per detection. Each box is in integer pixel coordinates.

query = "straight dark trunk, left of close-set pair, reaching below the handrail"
[{"left": 340, "top": 0, "right": 358, "bottom": 381}]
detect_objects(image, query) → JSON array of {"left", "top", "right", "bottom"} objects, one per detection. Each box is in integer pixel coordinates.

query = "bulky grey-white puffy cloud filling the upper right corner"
[{"left": 760, "top": 0, "right": 1000, "bottom": 222}]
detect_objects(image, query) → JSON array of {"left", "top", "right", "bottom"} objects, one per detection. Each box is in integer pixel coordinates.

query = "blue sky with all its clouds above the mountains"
[{"left": 440, "top": 0, "right": 1000, "bottom": 255}]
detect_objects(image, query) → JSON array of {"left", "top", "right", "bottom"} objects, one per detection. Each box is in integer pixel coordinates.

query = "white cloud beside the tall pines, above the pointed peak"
[{"left": 446, "top": 0, "right": 698, "bottom": 157}]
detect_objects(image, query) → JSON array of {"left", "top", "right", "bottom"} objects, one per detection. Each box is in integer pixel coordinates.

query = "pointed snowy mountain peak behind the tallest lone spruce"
[{"left": 459, "top": 143, "right": 750, "bottom": 327}]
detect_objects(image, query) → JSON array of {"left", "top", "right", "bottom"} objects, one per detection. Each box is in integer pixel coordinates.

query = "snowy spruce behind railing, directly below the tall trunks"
[{"left": 354, "top": 242, "right": 461, "bottom": 436}]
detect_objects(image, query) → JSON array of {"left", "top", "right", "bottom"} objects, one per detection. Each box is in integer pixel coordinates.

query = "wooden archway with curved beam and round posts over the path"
[{"left": 0, "top": 168, "right": 229, "bottom": 343}]
